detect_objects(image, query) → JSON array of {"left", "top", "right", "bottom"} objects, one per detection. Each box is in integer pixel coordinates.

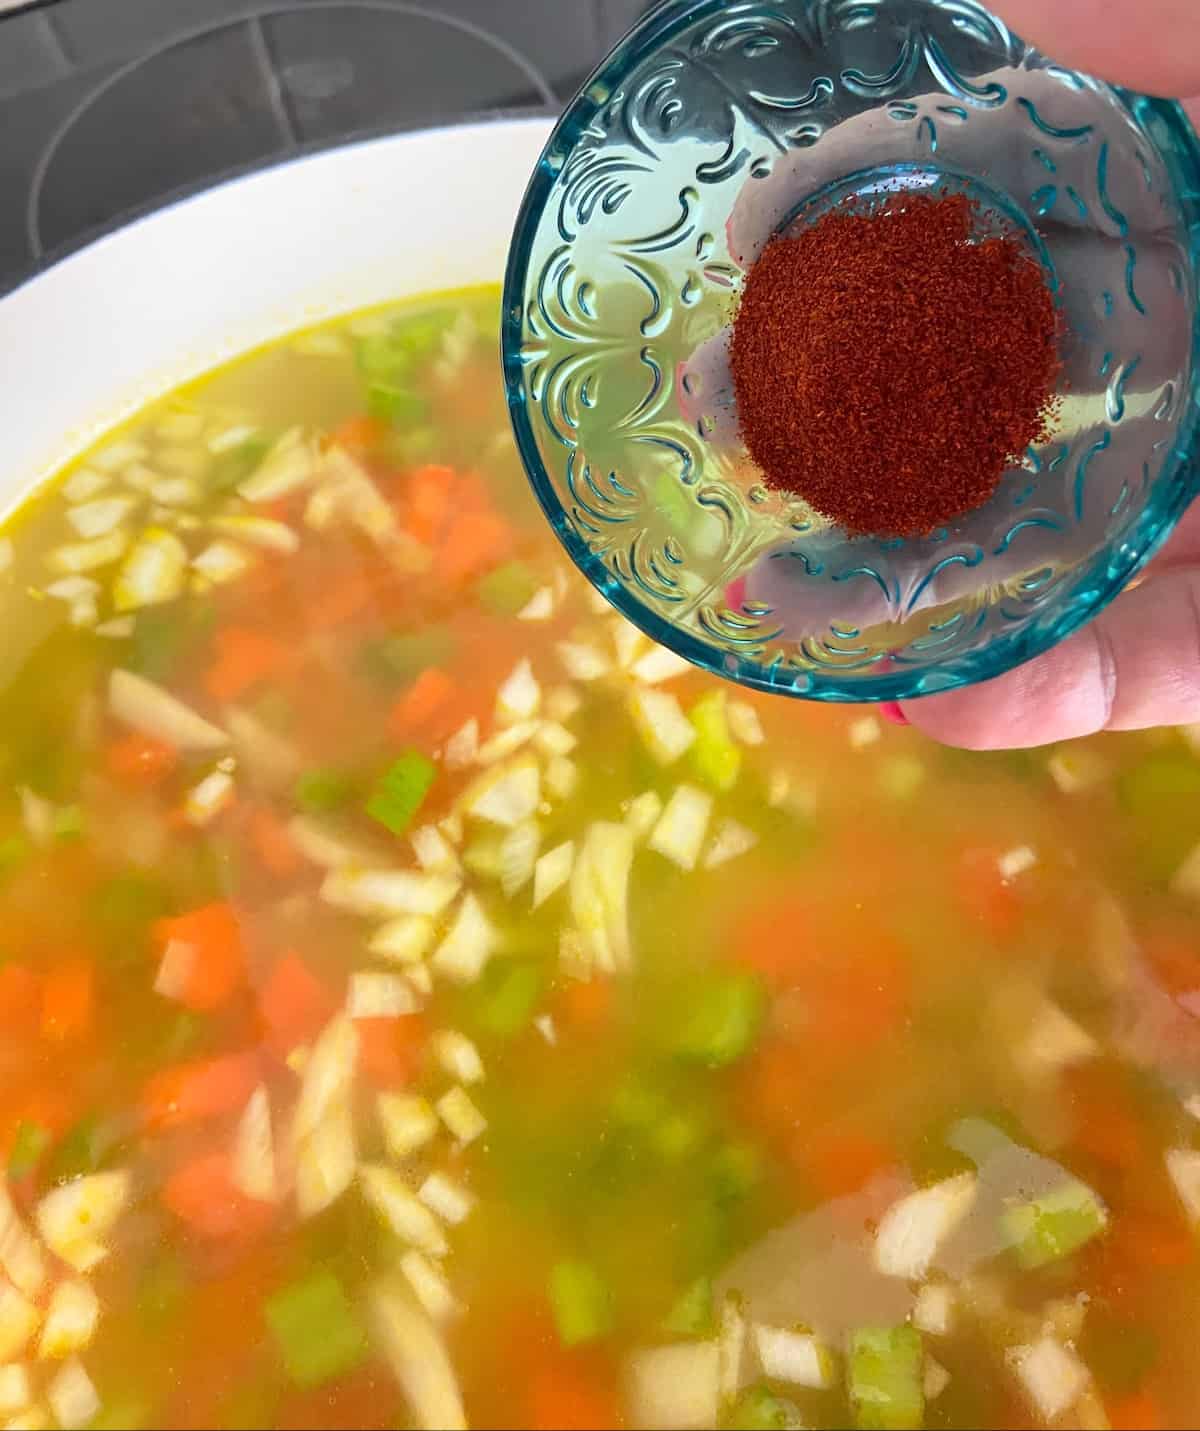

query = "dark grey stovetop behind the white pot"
[{"left": 0, "top": 0, "right": 648, "bottom": 293}]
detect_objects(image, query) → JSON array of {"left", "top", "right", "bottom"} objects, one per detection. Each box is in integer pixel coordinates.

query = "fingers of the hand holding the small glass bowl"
[{"left": 903, "top": 0, "right": 1200, "bottom": 750}]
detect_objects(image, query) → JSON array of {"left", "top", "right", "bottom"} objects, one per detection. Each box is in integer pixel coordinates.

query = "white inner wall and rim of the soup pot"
[{"left": 0, "top": 120, "right": 549, "bottom": 514}]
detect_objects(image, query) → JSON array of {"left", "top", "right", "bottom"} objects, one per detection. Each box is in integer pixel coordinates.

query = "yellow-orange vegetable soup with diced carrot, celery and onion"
[{"left": 0, "top": 289, "right": 1200, "bottom": 1428}]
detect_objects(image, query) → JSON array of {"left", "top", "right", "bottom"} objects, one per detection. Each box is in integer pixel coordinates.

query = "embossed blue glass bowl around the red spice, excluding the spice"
[{"left": 502, "top": 0, "right": 1200, "bottom": 701}]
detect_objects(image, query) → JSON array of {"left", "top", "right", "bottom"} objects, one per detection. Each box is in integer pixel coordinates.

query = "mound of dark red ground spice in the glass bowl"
[{"left": 729, "top": 195, "right": 1061, "bottom": 537}]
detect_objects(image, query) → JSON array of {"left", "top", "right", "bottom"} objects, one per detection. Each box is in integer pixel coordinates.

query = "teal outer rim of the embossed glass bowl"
[{"left": 501, "top": 0, "right": 1200, "bottom": 704}]
